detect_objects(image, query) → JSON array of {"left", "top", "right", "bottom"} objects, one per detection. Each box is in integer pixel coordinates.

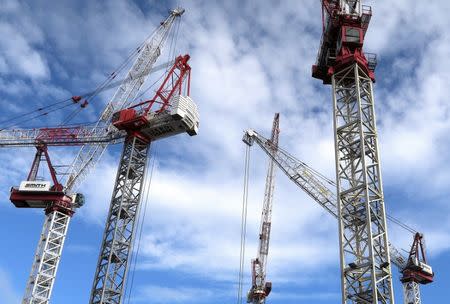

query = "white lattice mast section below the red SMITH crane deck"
[{"left": 22, "top": 210, "right": 70, "bottom": 304}]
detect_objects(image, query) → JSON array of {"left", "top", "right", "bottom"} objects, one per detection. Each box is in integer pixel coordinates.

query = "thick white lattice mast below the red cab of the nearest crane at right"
[{"left": 332, "top": 63, "right": 394, "bottom": 304}]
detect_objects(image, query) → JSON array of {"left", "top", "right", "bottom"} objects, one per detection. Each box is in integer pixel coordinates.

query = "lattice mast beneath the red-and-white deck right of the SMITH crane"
[{"left": 89, "top": 135, "right": 149, "bottom": 304}]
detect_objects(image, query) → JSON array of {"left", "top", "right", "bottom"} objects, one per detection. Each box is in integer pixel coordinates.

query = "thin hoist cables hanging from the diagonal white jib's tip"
[{"left": 237, "top": 146, "right": 250, "bottom": 304}]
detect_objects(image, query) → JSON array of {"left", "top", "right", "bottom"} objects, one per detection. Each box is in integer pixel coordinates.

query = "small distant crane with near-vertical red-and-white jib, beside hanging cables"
[{"left": 247, "top": 113, "right": 280, "bottom": 304}]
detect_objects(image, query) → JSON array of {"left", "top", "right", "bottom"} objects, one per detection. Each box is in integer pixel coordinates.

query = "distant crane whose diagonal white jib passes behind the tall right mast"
[{"left": 243, "top": 129, "right": 434, "bottom": 304}]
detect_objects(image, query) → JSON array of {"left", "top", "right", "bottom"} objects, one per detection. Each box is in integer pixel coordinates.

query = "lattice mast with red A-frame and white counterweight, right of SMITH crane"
[{"left": 89, "top": 55, "right": 198, "bottom": 304}]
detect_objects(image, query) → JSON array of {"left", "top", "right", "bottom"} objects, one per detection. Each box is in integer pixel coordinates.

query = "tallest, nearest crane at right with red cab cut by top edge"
[{"left": 312, "top": 0, "right": 394, "bottom": 304}]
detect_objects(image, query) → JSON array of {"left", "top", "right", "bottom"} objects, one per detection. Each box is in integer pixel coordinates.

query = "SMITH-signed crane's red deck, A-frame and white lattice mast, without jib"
[{"left": 16, "top": 145, "right": 84, "bottom": 304}]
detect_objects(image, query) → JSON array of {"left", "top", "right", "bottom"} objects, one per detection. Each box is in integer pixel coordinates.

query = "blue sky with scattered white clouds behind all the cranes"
[{"left": 0, "top": 0, "right": 450, "bottom": 304}]
